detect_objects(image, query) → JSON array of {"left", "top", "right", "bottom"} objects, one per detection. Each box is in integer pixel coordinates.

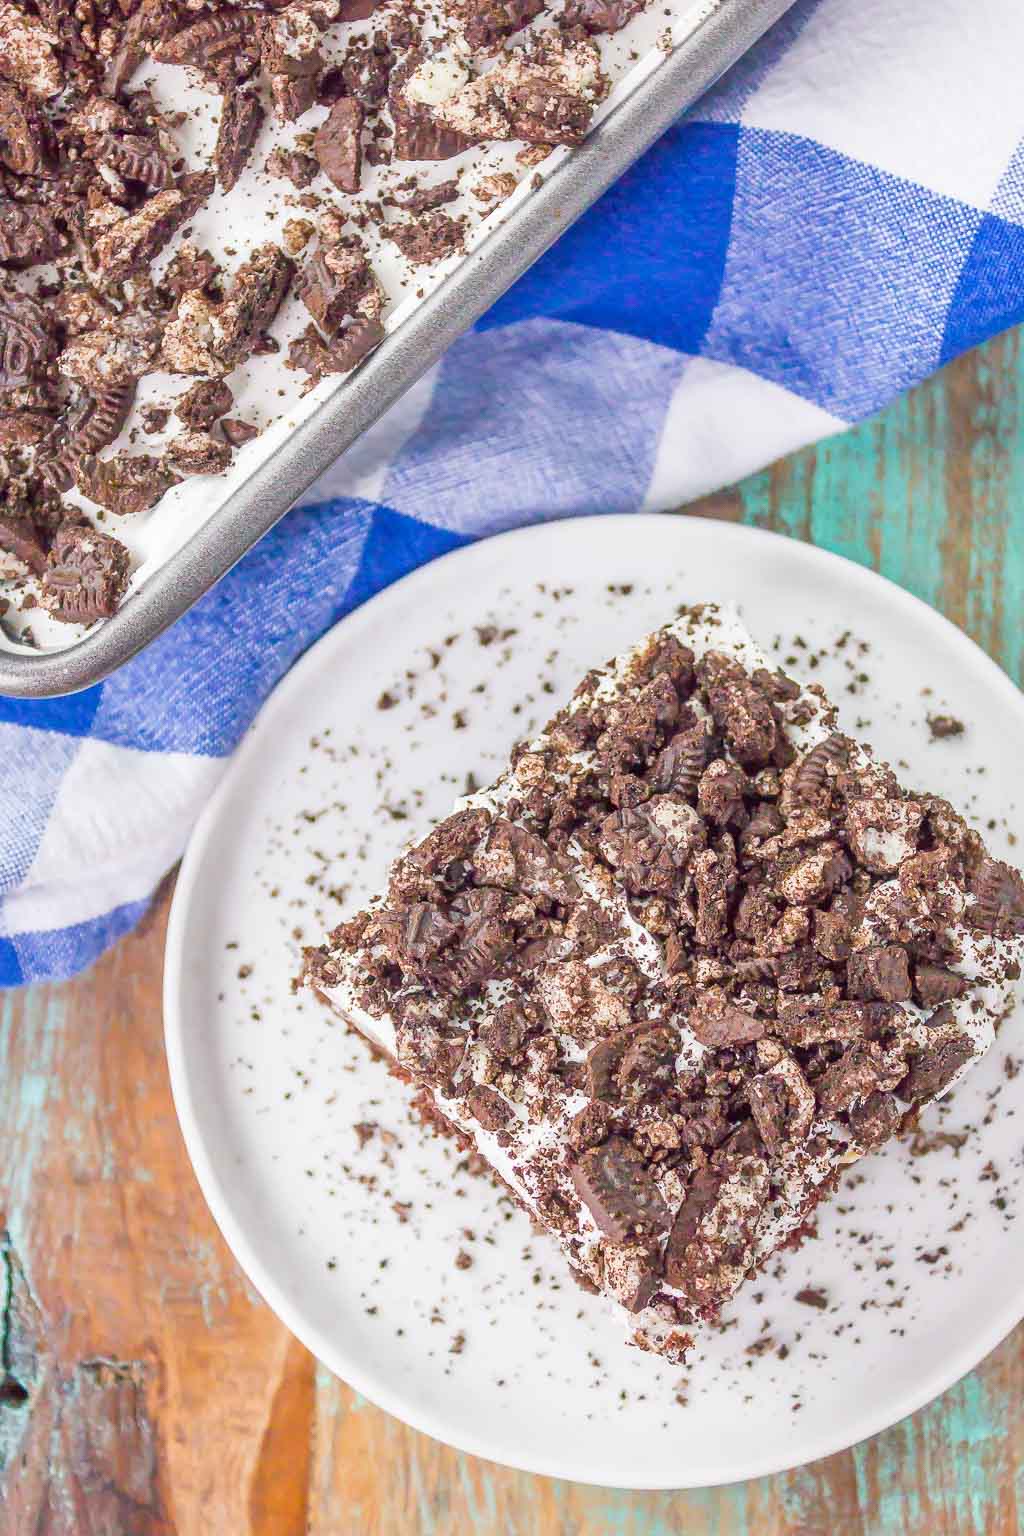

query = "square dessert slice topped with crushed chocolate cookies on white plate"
[{"left": 302, "top": 605, "right": 1024, "bottom": 1358}]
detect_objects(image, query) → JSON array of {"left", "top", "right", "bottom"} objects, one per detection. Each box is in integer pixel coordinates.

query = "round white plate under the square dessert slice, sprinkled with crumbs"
[{"left": 166, "top": 516, "right": 1024, "bottom": 1488}]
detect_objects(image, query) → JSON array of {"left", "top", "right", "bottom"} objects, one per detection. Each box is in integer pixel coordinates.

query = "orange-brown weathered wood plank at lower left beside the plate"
[{"left": 0, "top": 900, "right": 313, "bottom": 1536}]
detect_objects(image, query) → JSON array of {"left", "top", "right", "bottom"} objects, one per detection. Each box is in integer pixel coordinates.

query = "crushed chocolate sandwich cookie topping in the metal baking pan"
[{"left": 0, "top": 0, "right": 684, "bottom": 629}]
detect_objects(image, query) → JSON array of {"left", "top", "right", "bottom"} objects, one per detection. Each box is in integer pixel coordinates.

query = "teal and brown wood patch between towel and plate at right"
[{"left": 735, "top": 333, "right": 1024, "bottom": 697}]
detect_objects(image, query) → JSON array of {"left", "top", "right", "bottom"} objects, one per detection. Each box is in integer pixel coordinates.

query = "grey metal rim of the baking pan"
[{"left": 0, "top": 0, "right": 792, "bottom": 697}]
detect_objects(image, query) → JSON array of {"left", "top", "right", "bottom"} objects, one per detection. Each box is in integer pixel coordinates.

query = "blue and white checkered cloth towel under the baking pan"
[{"left": 0, "top": 0, "right": 1024, "bottom": 985}]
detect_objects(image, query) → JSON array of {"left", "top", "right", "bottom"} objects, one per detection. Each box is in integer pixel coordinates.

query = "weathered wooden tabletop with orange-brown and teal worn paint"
[{"left": 0, "top": 332, "right": 1024, "bottom": 1536}]
